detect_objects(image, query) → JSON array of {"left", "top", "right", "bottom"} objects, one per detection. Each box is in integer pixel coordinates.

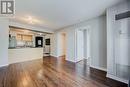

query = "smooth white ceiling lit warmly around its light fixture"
[{"left": 11, "top": 0, "right": 123, "bottom": 30}]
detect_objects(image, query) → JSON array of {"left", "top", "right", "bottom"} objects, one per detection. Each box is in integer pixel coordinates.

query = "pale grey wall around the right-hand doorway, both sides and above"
[{"left": 52, "top": 16, "right": 107, "bottom": 69}]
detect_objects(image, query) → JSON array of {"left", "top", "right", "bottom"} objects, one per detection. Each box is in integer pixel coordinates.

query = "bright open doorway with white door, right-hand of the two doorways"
[{"left": 75, "top": 28, "right": 90, "bottom": 64}]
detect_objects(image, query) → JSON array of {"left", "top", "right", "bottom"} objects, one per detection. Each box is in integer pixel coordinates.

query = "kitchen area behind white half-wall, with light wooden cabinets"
[{"left": 8, "top": 26, "right": 52, "bottom": 64}]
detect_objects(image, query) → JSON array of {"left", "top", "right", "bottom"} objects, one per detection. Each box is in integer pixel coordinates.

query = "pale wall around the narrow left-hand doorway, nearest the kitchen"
[{"left": 51, "top": 28, "right": 75, "bottom": 62}]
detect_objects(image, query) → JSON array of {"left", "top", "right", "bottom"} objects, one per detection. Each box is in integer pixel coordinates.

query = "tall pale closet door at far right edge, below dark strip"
[{"left": 115, "top": 18, "right": 130, "bottom": 80}]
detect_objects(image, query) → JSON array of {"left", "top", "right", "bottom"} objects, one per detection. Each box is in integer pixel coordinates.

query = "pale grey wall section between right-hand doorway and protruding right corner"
[{"left": 90, "top": 16, "right": 107, "bottom": 69}]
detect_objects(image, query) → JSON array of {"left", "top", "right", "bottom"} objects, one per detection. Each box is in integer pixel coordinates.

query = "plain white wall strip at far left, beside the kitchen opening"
[{"left": 0, "top": 18, "right": 9, "bottom": 67}]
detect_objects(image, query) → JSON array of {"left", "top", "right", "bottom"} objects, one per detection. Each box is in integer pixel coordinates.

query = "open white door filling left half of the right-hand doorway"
[{"left": 76, "top": 30, "right": 84, "bottom": 62}]
